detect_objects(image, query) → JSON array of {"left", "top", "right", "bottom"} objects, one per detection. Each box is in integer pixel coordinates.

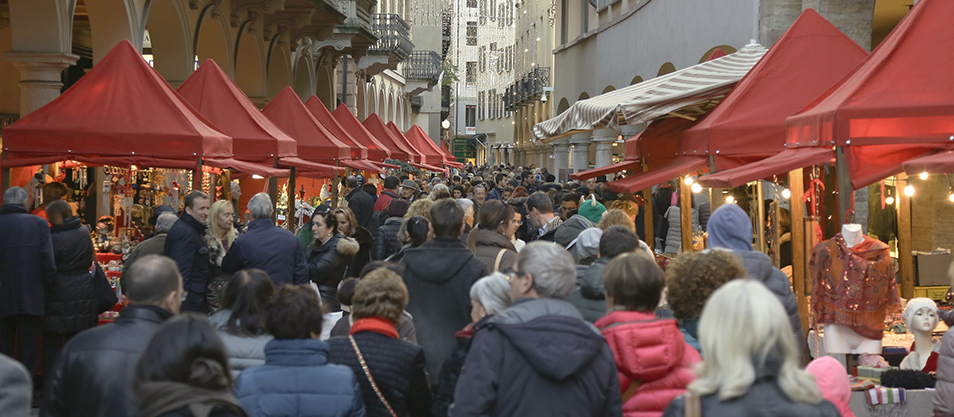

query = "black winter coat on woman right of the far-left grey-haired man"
[{"left": 43, "top": 216, "right": 99, "bottom": 333}]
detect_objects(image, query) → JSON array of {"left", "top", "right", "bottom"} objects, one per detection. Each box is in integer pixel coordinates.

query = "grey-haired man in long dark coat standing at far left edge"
[{"left": 0, "top": 187, "right": 56, "bottom": 375}]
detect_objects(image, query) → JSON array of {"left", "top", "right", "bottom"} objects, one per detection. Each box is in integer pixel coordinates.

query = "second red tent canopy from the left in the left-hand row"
[{"left": 178, "top": 59, "right": 297, "bottom": 176}]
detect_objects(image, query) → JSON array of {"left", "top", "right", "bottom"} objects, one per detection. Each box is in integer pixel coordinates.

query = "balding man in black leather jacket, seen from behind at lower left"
[{"left": 40, "top": 255, "right": 184, "bottom": 417}]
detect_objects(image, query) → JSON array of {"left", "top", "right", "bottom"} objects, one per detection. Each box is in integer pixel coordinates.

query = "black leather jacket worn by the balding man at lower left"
[{"left": 40, "top": 305, "right": 172, "bottom": 417}]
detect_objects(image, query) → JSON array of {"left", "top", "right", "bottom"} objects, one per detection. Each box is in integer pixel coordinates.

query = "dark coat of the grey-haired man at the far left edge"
[{"left": 0, "top": 204, "right": 56, "bottom": 317}]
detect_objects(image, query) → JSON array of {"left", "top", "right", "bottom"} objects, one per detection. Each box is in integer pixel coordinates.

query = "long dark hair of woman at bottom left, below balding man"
[{"left": 133, "top": 313, "right": 232, "bottom": 392}]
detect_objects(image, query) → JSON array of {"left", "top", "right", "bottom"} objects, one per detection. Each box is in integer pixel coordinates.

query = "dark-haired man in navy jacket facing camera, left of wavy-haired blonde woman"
[{"left": 164, "top": 191, "right": 211, "bottom": 314}]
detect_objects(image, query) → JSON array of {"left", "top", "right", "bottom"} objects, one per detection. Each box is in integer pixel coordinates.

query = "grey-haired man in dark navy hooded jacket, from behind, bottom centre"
[{"left": 450, "top": 242, "right": 622, "bottom": 417}]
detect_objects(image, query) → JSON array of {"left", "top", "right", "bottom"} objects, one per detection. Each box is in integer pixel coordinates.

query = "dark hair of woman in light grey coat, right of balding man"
[{"left": 222, "top": 269, "right": 275, "bottom": 337}]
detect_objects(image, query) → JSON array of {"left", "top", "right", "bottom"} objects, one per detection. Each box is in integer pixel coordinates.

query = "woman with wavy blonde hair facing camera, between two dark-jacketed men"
[{"left": 205, "top": 200, "right": 238, "bottom": 312}]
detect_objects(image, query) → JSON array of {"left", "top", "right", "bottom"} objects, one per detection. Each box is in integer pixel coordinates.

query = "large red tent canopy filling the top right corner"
[{"left": 787, "top": 0, "right": 954, "bottom": 189}]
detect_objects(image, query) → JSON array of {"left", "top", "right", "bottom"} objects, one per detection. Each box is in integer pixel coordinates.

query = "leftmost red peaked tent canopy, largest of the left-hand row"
[{"left": 3, "top": 40, "right": 232, "bottom": 169}]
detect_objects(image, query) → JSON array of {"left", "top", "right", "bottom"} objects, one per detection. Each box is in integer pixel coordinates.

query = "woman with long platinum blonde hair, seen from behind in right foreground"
[{"left": 663, "top": 279, "right": 840, "bottom": 417}]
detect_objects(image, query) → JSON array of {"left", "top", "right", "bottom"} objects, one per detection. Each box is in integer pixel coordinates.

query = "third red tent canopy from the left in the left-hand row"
[{"left": 262, "top": 87, "right": 351, "bottom": 165}]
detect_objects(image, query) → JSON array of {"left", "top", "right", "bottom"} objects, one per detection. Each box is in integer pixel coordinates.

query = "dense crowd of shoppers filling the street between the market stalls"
[{"left": 0, "top": 166, "right": 954, "bottom": 417}]
